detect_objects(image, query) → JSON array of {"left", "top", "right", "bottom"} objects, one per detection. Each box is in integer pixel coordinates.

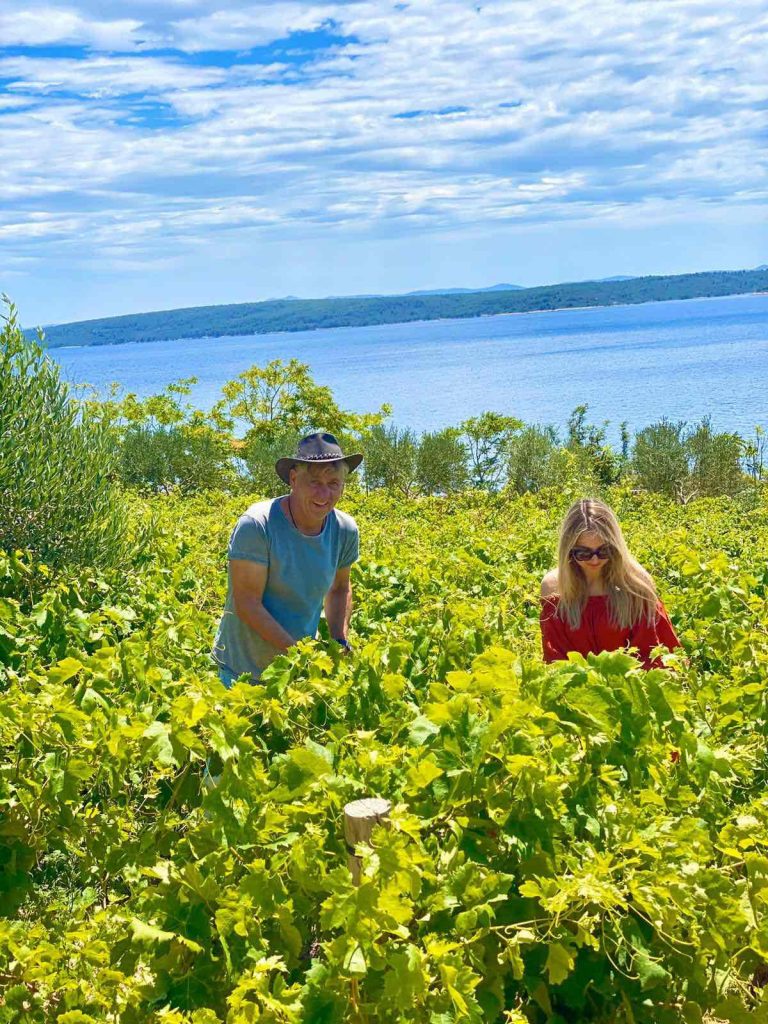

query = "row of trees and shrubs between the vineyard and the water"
[{"left": 67, "top": 346, "right": 765, "bottom": 502}]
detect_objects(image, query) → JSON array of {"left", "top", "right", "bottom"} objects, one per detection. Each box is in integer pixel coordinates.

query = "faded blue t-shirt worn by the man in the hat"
[{"left": 213, "top": 498, "right": 359, "bottom": 679}]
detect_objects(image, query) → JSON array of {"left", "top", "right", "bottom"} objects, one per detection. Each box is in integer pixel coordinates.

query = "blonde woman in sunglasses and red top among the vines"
[{"left": 541, "top": 499, "right": 680, "bottom": 669}]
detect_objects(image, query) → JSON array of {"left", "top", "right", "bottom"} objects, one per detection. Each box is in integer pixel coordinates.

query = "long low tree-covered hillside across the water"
[{"left": 29, "top": 269, "right": 768, "bottom": 348}]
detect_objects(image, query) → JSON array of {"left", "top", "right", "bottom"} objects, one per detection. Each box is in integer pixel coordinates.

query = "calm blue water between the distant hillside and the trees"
[{"left": 51, "top": 295, "right": 768, "bottom": 433}]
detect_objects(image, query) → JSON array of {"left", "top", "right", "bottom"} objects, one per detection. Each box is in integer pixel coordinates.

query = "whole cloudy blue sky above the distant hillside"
[{"left": 0, "top": 0, "right": 768, "bottom": 325}]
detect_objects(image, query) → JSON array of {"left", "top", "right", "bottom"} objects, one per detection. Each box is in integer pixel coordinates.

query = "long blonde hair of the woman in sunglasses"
[{"left": 557, "top": 498, "right": 658, "bottom": 629}]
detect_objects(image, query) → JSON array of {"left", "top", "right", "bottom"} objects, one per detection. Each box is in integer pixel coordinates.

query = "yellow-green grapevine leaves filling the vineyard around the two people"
[{"left": 0, "top": 488, "right": 768, "bottom": 1024}]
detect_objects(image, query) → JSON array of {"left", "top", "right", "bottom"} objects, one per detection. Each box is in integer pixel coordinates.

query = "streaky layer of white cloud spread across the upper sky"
[{"left": 0, "top": 0, "right": 768, "bottom": 284}]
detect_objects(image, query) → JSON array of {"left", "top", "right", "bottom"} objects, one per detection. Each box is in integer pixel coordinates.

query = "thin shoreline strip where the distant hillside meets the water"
[{"left": 40, "top": 290, "right": 768, "bottom": 353}]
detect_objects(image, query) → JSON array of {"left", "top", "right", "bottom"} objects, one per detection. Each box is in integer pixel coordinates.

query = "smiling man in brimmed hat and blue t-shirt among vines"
[{"left": 213, "top": 433, "right": 362, "bottom": 687}]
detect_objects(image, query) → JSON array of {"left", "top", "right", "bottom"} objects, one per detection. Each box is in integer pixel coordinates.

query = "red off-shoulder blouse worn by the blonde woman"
[{"left": 541, "top": 595, "right": 680, "bottom": 669}]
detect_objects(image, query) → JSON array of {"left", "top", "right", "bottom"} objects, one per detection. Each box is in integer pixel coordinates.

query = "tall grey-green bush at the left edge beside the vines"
[{"left": 0, "top": 304, "right": 126, "bottom": 567}]
